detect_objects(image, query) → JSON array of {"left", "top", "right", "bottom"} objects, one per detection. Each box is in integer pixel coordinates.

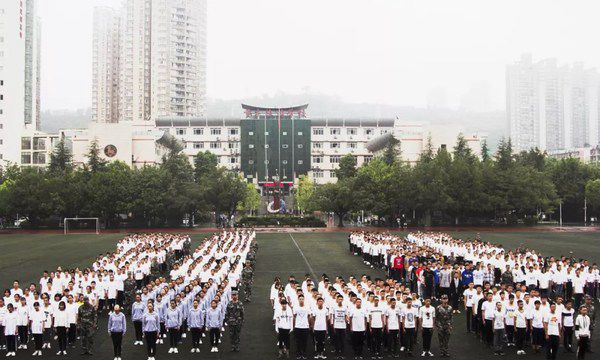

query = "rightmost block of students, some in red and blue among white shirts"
[{"left": 348, "top": 232, "right": 600, "bottom": 359}]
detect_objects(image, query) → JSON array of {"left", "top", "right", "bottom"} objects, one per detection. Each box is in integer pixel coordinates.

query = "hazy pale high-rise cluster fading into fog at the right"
[{"left": 506, "top": 54, "right": 599, "bottom": 151}]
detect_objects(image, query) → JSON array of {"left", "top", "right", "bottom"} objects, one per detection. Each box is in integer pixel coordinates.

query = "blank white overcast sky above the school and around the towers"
[{"left": 39, "top": 0, "right": 600, "bottom": 109}]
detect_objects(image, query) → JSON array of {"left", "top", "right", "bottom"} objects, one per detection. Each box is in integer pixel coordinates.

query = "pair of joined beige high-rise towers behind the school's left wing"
[{"left": 93, "top": 0, "right": 207, "bottom": 122}]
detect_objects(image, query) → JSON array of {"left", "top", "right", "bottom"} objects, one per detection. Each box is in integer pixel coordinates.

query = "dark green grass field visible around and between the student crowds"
[{"left": 0, "top": 232, "right": 600, "bottom": 359}]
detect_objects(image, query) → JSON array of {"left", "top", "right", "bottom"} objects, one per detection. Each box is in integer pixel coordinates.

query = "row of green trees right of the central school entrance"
[{"left": 296, "top": 135, "right": 600, "bottom": 226}]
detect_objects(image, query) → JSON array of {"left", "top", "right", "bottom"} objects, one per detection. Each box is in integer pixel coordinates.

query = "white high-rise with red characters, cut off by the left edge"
[{"left": 0, "top": 0, "right": 41, "bottom": 164}]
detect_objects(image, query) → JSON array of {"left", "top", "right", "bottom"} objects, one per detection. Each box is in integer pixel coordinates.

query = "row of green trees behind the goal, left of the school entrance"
[{"left": 0, "top": 138, "right": 260, "bottom": 227}]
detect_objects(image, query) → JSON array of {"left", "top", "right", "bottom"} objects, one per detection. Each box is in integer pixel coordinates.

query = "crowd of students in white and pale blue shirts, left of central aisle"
[{"left": 0, "top": 231, "right": 255, "bottom": 360}]
